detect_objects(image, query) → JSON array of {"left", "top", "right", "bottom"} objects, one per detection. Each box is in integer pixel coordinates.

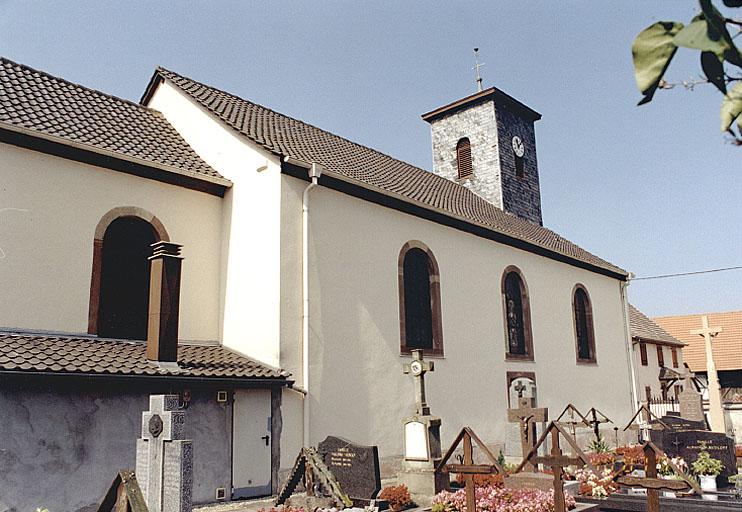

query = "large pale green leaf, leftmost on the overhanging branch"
[{"left": 631, "top": 21, "right": 683, "bottom": 105}]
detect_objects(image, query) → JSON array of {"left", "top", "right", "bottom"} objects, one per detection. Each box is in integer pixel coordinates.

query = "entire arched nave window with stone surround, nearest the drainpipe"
[{"left": 398, "top": 242, "right": 443, "bottom": 355}]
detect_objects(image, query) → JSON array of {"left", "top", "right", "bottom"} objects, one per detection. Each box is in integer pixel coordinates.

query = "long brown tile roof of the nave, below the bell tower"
[{"left": 148, "top": 68, "right": 626, "bottom": 276}]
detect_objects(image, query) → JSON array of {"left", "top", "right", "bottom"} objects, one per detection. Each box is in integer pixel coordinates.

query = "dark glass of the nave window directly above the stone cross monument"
[{"left": 404, "top": 248, "right": 433, "bottom": 349}]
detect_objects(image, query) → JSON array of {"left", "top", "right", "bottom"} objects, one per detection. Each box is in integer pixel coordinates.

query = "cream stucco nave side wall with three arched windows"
[{"left": 282, "top": 176, "right": 632, "bottom": 466}]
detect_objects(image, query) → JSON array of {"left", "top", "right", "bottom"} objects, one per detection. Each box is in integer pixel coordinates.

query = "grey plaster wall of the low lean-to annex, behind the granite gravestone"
[{"left": 0, "top": 382, "right": 232, "bottom": 512}]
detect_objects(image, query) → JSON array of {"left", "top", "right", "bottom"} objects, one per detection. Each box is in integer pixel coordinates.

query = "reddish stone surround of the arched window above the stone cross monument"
[{"left": 397, "top": 240, "right": 443, "bottom": 357}]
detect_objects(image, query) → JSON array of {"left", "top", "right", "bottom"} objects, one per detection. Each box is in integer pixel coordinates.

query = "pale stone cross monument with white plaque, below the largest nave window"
[{"left": 398, "top": 350, "right": 448, "bottom": 505}]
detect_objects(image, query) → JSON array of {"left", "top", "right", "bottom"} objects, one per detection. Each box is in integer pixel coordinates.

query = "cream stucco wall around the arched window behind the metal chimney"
[{"left": 0, "top": 144, "right": 222, "bottom": 340}]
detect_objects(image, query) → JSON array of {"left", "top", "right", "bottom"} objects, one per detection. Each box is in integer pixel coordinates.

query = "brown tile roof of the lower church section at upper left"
[{"left": 0, "top": 57, "right": 229, "bottom": 184}]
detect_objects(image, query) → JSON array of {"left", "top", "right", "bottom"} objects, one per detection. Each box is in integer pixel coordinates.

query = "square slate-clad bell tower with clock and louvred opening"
[{"left": 422, "top": 87, "right": 543, "bottom": 225}]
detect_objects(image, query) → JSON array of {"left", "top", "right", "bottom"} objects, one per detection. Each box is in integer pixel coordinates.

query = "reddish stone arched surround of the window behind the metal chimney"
[{"left": 88, "top": 206, "right": 170, "bottom": 334}]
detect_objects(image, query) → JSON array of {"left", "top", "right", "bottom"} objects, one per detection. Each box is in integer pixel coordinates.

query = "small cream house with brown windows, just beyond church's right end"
[{"left": 629, "top": 304, "right": 685, "bottom": 401}]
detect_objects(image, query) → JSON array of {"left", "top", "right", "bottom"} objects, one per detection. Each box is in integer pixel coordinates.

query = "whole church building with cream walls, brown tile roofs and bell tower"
[{"left": 0, "top": 60, "right": 636, "bottom": 512}]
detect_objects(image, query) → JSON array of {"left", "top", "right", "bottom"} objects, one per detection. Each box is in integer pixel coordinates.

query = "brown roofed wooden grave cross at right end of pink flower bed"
[{"left": 514, "top": 421, "right": 595, "bottom": 512}]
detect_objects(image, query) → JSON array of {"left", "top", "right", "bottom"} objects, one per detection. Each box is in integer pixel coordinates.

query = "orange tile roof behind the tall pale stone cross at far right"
[{"left": 654, "top": 311, "right": 742, "bottom": 372}]
